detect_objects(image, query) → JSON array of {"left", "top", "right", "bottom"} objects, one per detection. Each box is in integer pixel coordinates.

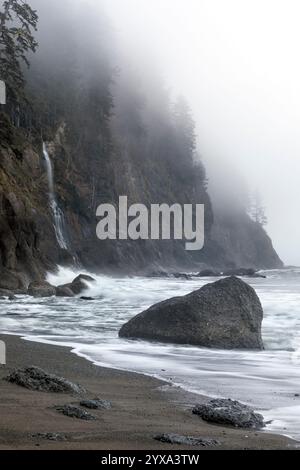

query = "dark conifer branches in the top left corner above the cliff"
[{"left": 0, "top": 0, "right": 38, "bottom": 105}]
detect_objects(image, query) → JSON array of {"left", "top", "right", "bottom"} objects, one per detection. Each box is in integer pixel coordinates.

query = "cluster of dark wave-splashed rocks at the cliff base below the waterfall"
[{"left": 0, "top": 271, "right": 95, "bottom": 300}]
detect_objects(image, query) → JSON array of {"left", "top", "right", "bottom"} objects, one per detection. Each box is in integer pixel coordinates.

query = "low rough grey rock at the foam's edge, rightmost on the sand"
[{"left": 193, "top": 400, "right": 265, "bottom": 429}]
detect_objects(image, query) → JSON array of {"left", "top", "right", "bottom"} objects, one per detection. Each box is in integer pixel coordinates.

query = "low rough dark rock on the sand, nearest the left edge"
[{"left": 5, "top": 367, "right": 85, "bottom": 394}]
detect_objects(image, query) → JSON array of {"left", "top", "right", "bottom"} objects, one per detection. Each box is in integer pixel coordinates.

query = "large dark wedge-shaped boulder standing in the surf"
[{"left": 119, "top": 277, "right": 263, "bottom": 350}]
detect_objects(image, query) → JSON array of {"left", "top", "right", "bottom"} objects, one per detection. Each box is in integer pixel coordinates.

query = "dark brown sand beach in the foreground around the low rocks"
[{"left": 0, "top": 335, "right": 296, "bottom": 450}]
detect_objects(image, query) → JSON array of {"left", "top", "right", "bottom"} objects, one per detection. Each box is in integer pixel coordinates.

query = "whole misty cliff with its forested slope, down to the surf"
[{"left": 0, "top": 1, "right": 282, "bottom": 280}]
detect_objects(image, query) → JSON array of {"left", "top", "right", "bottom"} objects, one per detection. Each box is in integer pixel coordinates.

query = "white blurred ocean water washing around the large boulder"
[{"left": 0, "top": 268, "right": 300, "bottom": 440}]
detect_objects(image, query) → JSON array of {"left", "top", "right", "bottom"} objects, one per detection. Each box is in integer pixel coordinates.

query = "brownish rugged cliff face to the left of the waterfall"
[{"left": 0, "top": 115, "right": 69, "bottom": 289}]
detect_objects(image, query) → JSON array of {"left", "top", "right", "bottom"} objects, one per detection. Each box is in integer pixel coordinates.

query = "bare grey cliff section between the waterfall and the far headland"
[{"left": 47, "top": 117, "right": 213, "bottom": 273}]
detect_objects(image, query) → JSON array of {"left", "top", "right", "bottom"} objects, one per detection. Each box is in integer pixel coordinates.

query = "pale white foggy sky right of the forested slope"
[{"left": 98, "top": 0, "right": 300, "bottom": 264}]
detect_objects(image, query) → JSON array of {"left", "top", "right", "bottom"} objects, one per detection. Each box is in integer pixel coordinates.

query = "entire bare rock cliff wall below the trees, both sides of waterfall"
[{"left": 0, "top": 98, "right": 282, "bottom": 282}]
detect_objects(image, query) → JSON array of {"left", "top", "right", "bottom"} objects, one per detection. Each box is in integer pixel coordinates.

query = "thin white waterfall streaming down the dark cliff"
[{"left": 43, "top": 142, "right": 68, "bottom": 250}]
